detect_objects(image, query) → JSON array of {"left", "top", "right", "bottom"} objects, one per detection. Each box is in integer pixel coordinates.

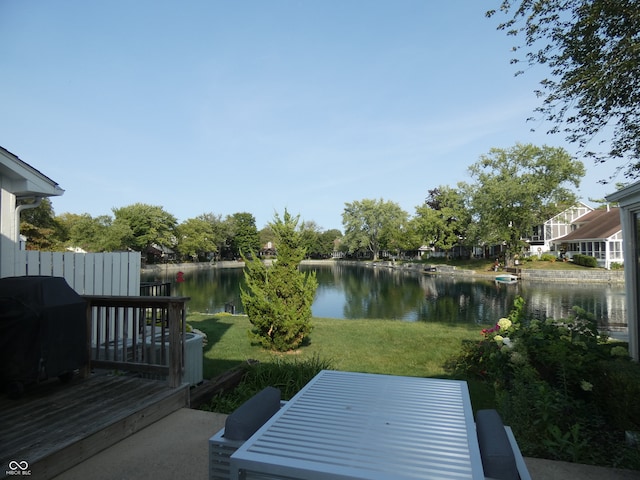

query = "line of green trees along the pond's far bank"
[{"left": 21, "top": 144, "right": 604, "bottom": 261}]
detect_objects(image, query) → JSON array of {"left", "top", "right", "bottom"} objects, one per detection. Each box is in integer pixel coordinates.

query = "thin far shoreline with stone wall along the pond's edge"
[{"left": 140, "top": 259, "right": 625, "bottom": 284}]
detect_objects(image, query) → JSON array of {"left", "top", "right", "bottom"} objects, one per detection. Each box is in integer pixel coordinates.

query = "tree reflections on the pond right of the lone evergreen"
[{"left": 304, "top": 265, "right": 626, "bottom": 330}]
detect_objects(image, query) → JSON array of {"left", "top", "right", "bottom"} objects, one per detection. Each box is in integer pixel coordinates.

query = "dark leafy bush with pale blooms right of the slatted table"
[{"left": 449, "top": 297, "right": 640, "bottom": 469}]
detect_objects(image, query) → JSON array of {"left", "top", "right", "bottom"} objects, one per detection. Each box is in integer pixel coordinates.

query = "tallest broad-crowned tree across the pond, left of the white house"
[{"left": 460, "top": 144, "right": 585, "bottom": 263}]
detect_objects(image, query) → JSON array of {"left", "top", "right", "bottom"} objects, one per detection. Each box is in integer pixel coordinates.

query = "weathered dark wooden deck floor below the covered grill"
[{"left": 0, "top": 373, "right": 189, "bottom": 479}]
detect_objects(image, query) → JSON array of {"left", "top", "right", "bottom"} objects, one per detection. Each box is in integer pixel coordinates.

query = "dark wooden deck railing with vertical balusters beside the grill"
[{"left": 82, "top": 295, "right": 189, "bottom": 388}]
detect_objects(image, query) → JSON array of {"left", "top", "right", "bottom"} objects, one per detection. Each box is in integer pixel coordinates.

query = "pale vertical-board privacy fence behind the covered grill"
[{"left": 14, "top": 250, "right": 140, "bottom": 295}]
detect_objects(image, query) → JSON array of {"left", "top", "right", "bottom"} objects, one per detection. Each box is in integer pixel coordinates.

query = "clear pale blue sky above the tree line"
[{"left": 0, "top": 0, "right": 616, "bottom": 229}]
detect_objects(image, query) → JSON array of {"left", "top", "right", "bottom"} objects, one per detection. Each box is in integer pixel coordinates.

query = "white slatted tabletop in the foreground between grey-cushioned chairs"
[{"left": 232, "top": 371, "right": 483, "bottom": 479}]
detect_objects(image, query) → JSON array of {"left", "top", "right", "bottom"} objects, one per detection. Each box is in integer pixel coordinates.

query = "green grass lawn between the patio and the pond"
[{"left": 187, "top": 314, "right": 493, "bottom": 409}]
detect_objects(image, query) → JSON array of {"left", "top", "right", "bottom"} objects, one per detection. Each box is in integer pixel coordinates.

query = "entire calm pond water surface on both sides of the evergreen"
[{"left": 142, "top": 264, "right": 627, "bottom": 334}]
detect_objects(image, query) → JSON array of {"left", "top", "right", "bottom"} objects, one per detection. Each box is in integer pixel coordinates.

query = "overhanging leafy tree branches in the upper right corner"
[{"left": 487, "top": 0, "right": 640, "bottom": 178}]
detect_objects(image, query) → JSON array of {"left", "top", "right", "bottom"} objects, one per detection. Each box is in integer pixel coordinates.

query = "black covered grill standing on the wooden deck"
[{"left": 0, "top": 277, "right": 88, "bottom": 385}]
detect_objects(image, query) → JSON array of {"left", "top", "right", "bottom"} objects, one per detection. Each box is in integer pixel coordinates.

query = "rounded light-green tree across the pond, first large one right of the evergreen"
[{"left": 342, "top": 199, "right": 408, "bottom": 260}]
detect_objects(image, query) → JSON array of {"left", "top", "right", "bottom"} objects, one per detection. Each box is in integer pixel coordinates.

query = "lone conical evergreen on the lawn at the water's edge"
[{"left": 240, "top": 210, "right": 318, "bottom": 351}]
